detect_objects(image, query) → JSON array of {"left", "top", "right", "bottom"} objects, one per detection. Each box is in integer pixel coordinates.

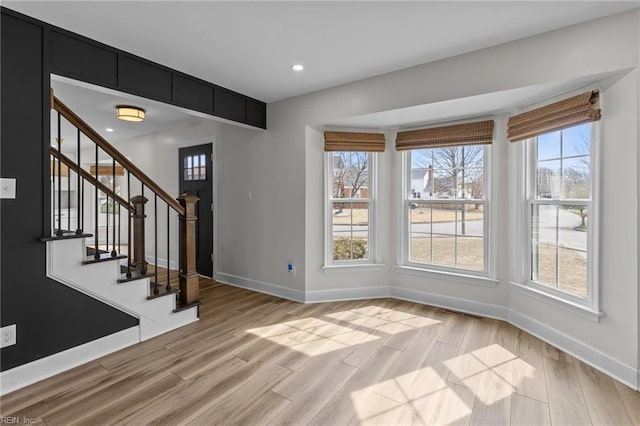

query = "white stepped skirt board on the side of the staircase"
[{"left": 47, "top": 239, "right": 198, "bottom": 341}]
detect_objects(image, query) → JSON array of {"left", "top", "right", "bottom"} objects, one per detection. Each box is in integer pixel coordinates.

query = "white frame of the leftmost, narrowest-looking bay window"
[{"left": 323, "top": 151, "right": 380, "bottom": 272}]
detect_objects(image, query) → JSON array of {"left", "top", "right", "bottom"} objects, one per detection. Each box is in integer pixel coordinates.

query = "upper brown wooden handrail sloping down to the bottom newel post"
[{"left": 52, "top": 96, "right": 185, "bottom": 216}]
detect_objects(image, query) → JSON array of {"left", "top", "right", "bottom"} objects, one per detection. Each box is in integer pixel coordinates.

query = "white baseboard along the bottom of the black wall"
[{"left": 0, "top": 326, "right": 140, "bottom": 395}]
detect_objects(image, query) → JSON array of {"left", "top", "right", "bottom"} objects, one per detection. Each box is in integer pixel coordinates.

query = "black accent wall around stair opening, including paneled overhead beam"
[{"left": 0, "top": 7, "right": 266, "bottom": 371}]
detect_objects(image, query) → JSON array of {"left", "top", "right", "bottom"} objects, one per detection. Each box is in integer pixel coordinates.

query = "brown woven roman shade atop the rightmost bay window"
[{"left": 507, "top": 91, "right": 600, "bottom": 142}]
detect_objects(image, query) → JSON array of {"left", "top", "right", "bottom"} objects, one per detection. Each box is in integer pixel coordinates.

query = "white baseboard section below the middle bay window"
[{"left": 391, "top": 286, "right": 507, "bottom": 320}]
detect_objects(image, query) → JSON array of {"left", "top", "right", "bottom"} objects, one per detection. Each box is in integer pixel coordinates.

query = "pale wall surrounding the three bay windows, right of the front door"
[{"left": 216, "top": 11, "right": 640, "bottom": 390}]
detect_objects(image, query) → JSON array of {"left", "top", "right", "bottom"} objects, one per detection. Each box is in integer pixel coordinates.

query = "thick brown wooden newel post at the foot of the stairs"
[{"left": 178, "top": 194, "right": 200, "bottom": 305}]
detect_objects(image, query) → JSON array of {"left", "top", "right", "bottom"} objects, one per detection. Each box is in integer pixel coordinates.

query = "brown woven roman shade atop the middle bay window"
[{"left": 396, "top": 120, "right": 493, "bottom": 151}]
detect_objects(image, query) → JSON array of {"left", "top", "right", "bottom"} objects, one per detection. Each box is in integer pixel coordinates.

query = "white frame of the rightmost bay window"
[{"left": 521, "top": 121, "right": 601, "bottom": 312}]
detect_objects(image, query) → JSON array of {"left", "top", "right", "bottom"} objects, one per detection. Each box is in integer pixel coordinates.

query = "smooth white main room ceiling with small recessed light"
[{"left": 2, "top": 0, "right": 640, "bottom": 102}]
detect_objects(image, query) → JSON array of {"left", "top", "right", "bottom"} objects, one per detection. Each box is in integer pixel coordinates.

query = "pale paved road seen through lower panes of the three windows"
[{"left": 334, "top": 208, "right": 587, "bottom": 250}]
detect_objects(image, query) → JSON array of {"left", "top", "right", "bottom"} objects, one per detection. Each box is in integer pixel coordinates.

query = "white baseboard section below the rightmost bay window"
[{"left": 508, "top": 310, "right": 640, "bottom": 390}]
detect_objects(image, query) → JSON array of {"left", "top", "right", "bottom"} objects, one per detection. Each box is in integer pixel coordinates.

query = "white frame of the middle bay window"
[{"left": 399, "top": 144, "right": 495, "bottom": 276}]
